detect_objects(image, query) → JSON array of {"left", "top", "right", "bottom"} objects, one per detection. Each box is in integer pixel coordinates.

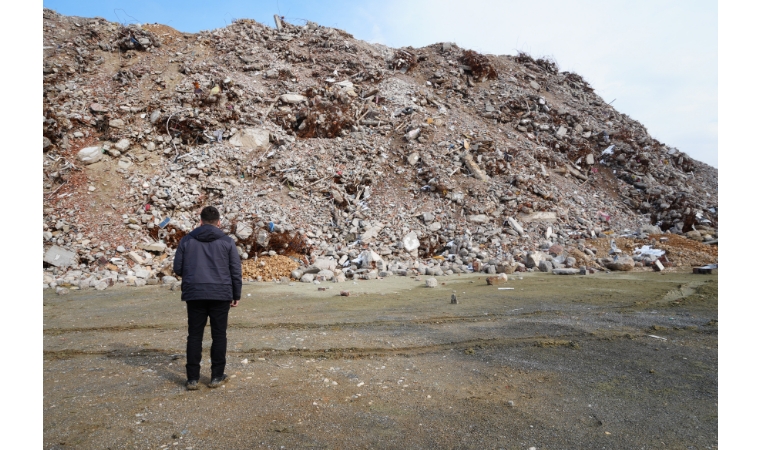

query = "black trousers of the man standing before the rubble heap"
[{"left": 185, "top": 300, "right": 232, "bottom": 380}]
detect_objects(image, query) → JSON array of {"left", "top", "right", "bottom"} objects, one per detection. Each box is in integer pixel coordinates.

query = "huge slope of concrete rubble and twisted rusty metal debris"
[{"left": 43, "top": 9, "right": 718, "bottom": 292}]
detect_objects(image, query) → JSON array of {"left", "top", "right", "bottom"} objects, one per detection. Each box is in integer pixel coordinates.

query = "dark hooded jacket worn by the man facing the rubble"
[{"left": 174, "top": 225, "right": 243, "bottom": 301}]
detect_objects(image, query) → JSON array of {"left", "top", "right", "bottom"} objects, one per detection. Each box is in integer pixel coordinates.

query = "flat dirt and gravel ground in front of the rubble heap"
[{"left": 43, "top": 272, "right": 718, "bottom": 450}]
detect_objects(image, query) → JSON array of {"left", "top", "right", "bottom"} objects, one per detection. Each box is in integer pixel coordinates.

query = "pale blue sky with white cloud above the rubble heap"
[{"left": 43, "top": 0, "right": 718, "bottom": 167}]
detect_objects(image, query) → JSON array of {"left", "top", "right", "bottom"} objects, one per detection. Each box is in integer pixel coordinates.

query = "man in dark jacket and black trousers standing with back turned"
[{"left": 174, "top": 206, "right": 243, "bottom": 391}]
